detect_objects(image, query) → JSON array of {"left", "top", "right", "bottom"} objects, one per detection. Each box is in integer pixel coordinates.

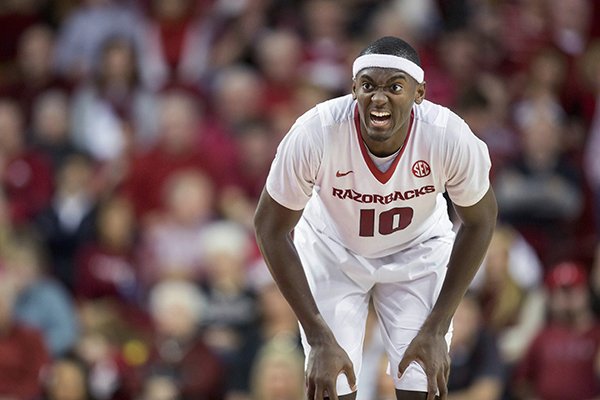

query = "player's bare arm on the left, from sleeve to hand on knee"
[{"left": 254, "top": 190, "right": 356, "bottom": 400}]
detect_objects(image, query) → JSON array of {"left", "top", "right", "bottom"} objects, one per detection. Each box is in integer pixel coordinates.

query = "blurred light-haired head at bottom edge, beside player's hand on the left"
[{"left": 251, "top": 336, "right": 305, "bottom": 400}]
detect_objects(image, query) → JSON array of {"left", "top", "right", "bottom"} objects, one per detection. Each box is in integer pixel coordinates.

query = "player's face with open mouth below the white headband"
[{"left": 352, "top": 68, "right": 425, "bottom": 156}]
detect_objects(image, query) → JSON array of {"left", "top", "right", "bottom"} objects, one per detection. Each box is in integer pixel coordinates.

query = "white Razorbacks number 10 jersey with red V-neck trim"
[{"left": 266, "top": 95, "right": 491, "bottom": 258}]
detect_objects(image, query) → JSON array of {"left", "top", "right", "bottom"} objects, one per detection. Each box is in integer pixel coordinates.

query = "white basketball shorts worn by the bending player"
[{"left": 294, "top": 220, "right": 452, "bottom": 395}]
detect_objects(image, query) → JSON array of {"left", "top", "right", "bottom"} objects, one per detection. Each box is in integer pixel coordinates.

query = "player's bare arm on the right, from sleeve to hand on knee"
[{"left": 398, "top": 187, "right": 498, "bottom": 400}]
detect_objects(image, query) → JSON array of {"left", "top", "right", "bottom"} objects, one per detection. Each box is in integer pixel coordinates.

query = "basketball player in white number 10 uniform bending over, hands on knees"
[{"left": 255, "top": 37, "right": 497, "bottom": 400}]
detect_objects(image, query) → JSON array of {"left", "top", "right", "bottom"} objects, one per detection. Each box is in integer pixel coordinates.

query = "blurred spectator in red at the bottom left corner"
[{"left": 0, "top": 275, "right": 50, "bottom": 400}]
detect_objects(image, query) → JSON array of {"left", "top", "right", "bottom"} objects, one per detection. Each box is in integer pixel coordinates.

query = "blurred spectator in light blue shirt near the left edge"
[{"left": 3, "top": 232, "right": 79, "bottom": 357}]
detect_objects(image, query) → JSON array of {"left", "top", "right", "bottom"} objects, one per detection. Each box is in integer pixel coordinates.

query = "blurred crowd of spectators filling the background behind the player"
[{"left": 0, "top": 0, "right": 600, "bottom": 400}]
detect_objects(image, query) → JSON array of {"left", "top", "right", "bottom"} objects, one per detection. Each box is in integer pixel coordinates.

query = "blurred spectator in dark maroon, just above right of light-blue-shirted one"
[{"left": 74, "top": 196, "right": 141, "bottom": 305}]
